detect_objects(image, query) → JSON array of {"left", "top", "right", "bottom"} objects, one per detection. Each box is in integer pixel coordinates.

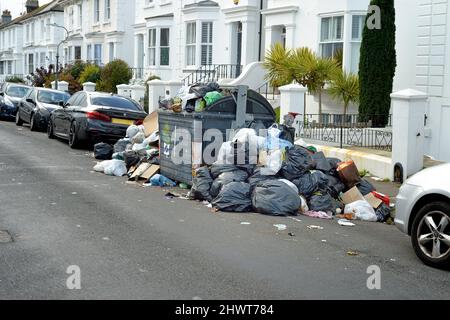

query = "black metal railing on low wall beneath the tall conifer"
[{"left": 295, "top": 114, "right": 392, "bottom": 151}]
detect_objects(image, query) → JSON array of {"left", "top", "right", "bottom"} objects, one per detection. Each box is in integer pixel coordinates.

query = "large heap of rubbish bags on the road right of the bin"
[{"left": 189, "top": 124, "right": 391, "bottom": 222}]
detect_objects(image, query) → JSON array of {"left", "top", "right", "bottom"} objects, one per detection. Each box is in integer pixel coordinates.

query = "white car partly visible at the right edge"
[{"left": 395, "top": 163, "right": 450, "bottom": 269}]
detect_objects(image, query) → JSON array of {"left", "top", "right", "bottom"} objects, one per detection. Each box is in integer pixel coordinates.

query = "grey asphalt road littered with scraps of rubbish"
[{"left": 0, "top": 122, "right": 450, "bottom": 300}]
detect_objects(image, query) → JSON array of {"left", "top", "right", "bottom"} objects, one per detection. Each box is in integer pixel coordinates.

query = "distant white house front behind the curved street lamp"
[{"left": 22, "top": 0, "right": 64, "bottom": 74}]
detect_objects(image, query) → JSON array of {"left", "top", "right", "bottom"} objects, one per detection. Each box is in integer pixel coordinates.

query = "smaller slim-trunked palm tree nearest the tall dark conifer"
[{"left": 328, "top": 71, "right": 359, "bottom": 119}]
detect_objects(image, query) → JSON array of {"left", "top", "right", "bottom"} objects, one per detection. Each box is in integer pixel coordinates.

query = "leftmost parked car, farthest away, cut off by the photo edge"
[{"left": 0, "top": 82, "right": 31, "bottom": 120}]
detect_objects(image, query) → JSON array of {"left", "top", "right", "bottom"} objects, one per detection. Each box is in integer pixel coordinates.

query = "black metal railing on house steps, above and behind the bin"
[{"left": 183, "top": 64, "right": 242, "bottom": 86}]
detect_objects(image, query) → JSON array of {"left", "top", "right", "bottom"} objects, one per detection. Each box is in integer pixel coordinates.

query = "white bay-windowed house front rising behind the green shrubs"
[{"left": 62, "top": 0, "right": 135, "bottom": 66}]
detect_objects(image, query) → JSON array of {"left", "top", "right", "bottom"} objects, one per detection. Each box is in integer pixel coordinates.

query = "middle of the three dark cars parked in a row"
[{"left": 16, "top": 88, "right": 70, "bottom": 131}]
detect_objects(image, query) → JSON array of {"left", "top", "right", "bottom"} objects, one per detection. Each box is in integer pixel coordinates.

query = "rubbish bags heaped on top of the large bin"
[{"left": 159, "top": 82, "right": 231, "bottom": 113}]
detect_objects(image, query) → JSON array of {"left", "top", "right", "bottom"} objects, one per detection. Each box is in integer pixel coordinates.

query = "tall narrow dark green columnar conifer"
[{"left": 359, "top": 0, "right": 397, "bottom": 127}]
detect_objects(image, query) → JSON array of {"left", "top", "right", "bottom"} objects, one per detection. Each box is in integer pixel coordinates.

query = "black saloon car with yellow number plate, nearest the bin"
[{"left": 47, "top": 91, "right": 147, "bottom": 148}]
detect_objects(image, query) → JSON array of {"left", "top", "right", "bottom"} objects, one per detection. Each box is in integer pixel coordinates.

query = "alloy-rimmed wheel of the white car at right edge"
[{"left": 411, "top": 202, "right": 450, "bottom": 269}]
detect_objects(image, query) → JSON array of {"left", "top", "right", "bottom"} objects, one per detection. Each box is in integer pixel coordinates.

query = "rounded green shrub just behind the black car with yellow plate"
[{"left": 97, "top": 59, "right": 132, "bottom": 93}]
